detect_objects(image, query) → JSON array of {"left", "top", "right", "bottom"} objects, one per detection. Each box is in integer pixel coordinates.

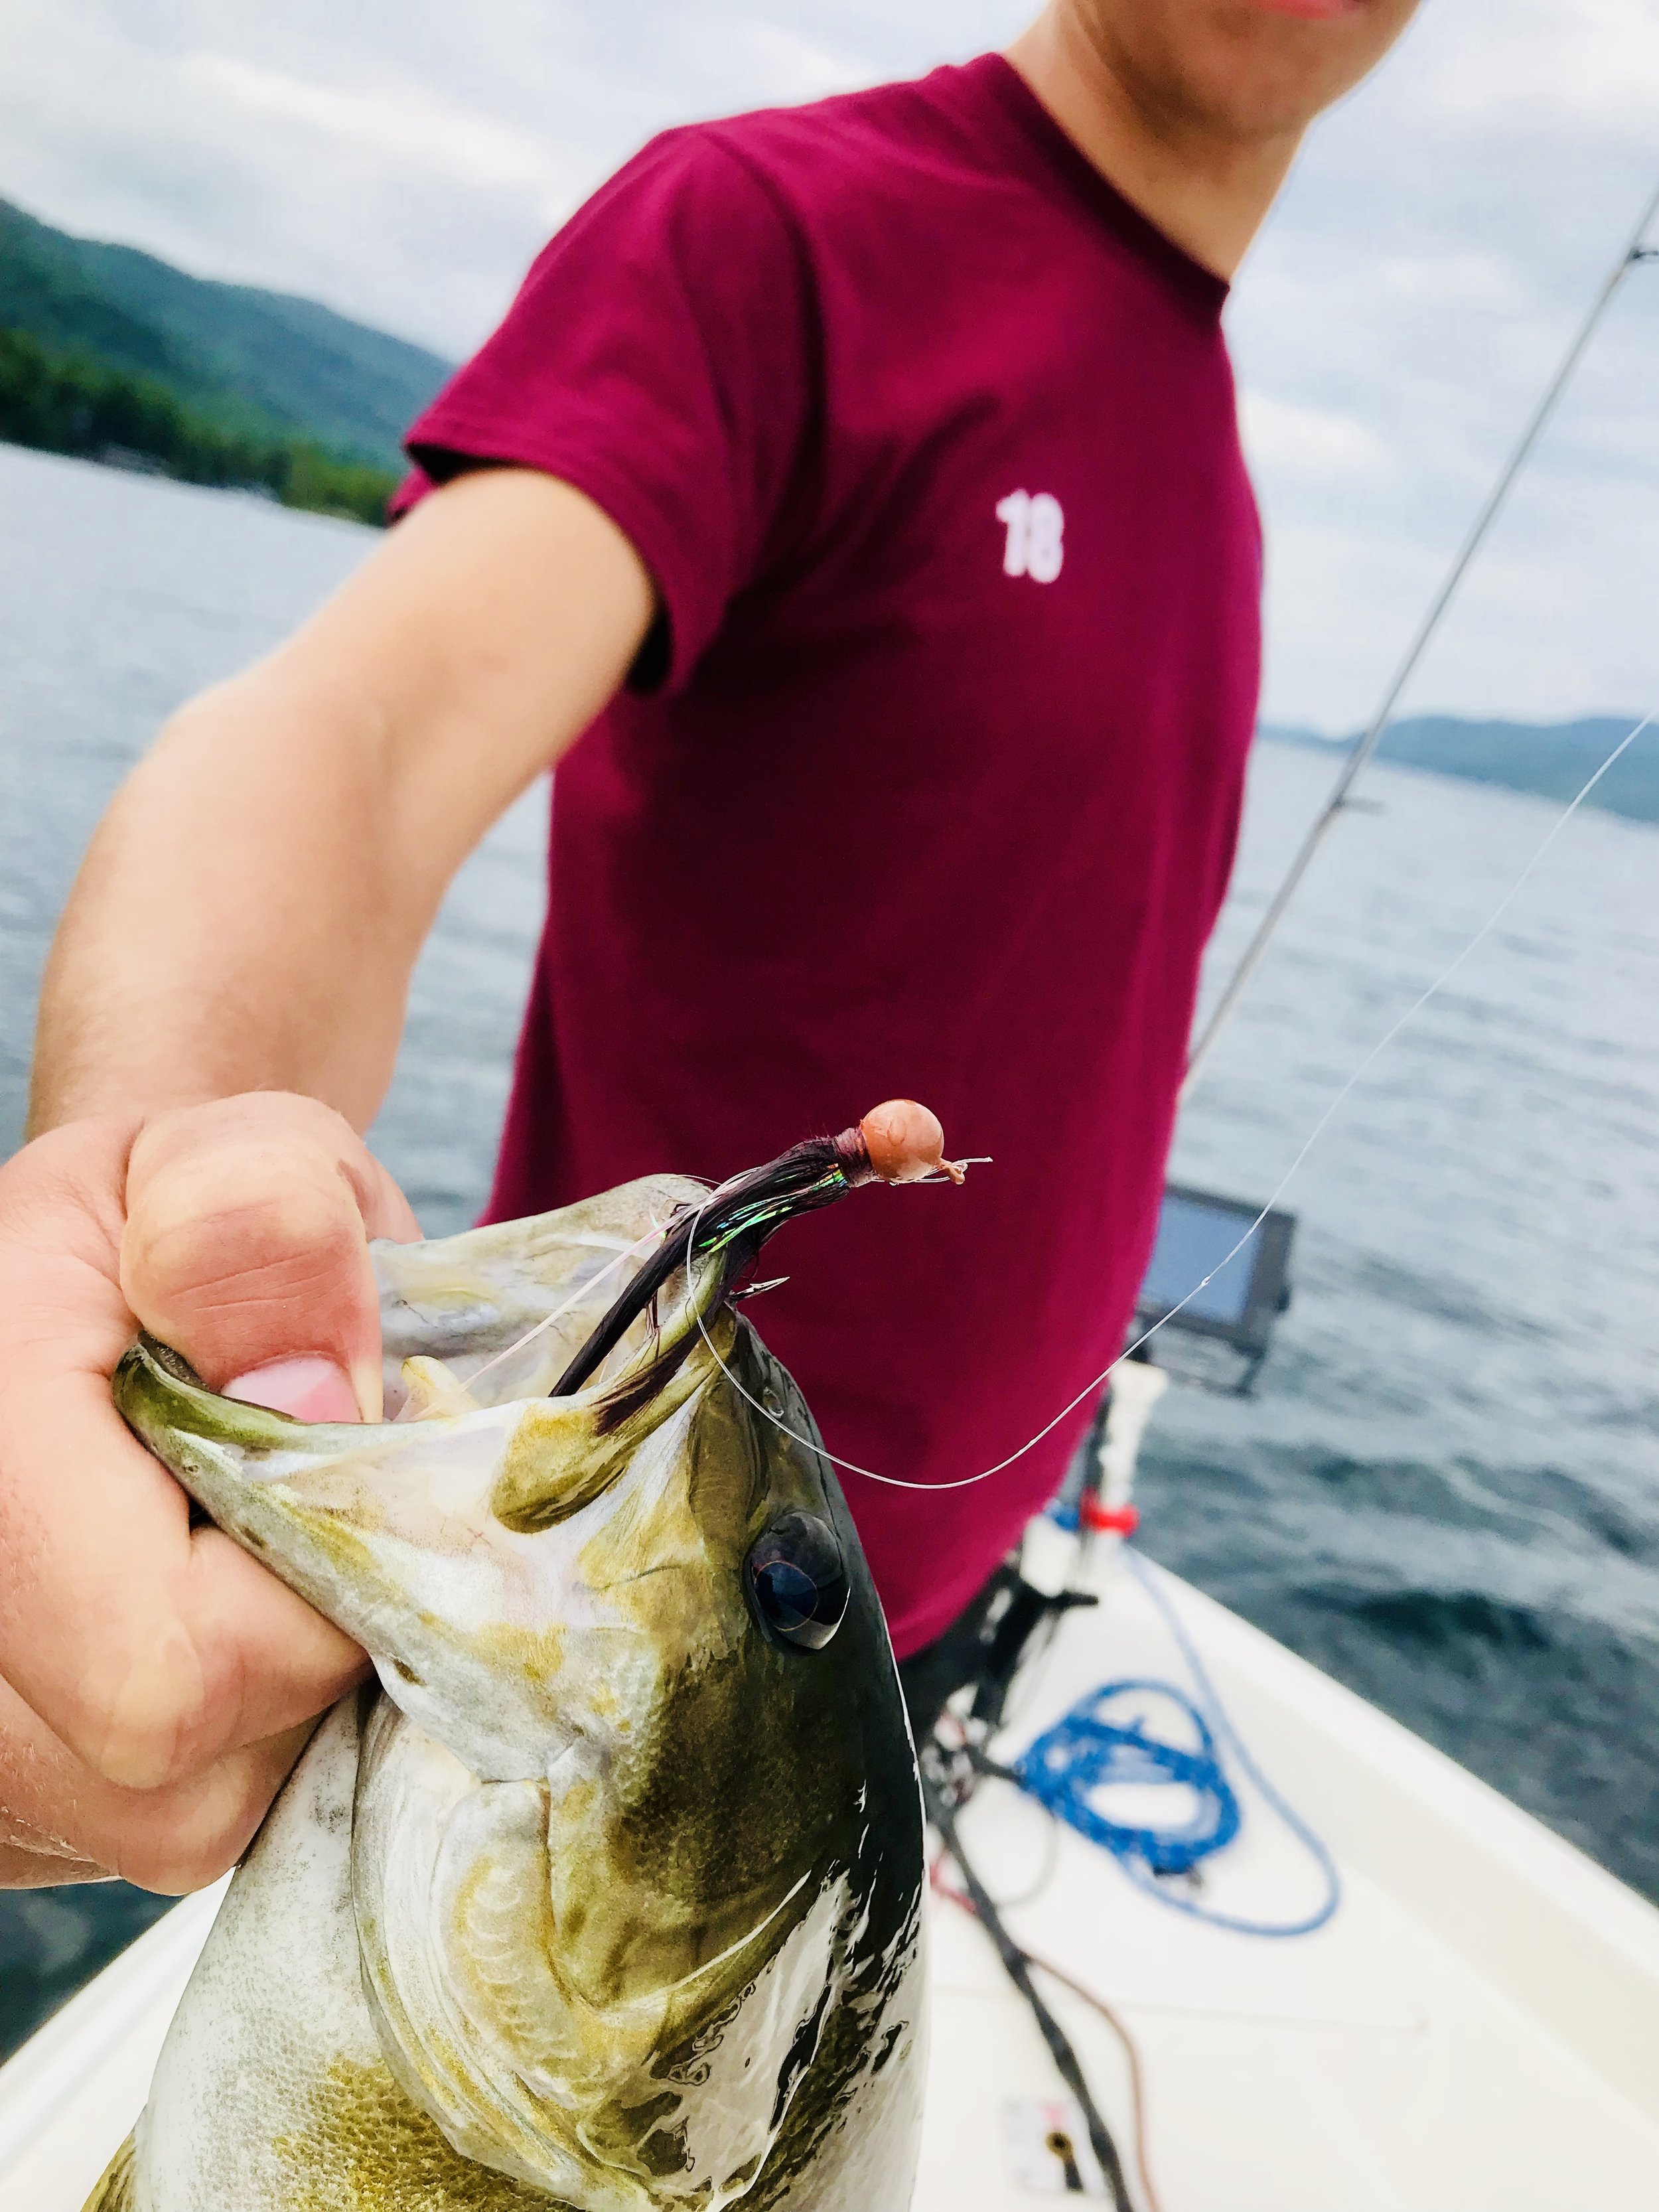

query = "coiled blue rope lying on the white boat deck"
[{"left": 1009, "top": 1544, "right": 1342, "bottom": 1935}]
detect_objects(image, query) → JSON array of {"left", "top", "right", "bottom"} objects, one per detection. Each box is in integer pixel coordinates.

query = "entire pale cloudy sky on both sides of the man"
[{"left": 0, "top": 0, "right": 1659, "bottom": 732}]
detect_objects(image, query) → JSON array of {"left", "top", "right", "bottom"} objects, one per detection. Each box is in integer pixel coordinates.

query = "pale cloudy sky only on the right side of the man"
[{"left": 1230, "top": 0, "right": 1659, "bottom": 730}]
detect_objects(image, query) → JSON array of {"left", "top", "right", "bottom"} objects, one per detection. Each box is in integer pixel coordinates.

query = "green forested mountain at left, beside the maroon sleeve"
[{"left": 0, "top": 201, "right": 449, "bottom": 516}]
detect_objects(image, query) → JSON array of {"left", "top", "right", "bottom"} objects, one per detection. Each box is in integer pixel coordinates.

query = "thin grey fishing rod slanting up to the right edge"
[{"left": 1181, "top": 168, "right": 1659, "bottom": 1100}]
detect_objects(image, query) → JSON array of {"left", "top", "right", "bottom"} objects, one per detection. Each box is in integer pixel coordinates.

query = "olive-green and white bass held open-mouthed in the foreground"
[{"left": 86, "top": 1132, "right": 946, "bottom": 2212}]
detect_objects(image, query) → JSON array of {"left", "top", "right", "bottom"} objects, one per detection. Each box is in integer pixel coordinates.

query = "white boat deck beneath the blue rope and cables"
[{"left": 0, "top": 1540, "right": 1659, "bottom": 2212}]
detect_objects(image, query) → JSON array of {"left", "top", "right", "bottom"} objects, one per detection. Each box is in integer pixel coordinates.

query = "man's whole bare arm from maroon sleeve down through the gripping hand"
[{"left": 0, "top": 471, "right": 652, "bottom": 1889}]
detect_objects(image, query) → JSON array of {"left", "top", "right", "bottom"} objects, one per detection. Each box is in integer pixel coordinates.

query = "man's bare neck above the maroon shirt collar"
[{"left": 1007, "top": 5, "right": 1301, "bottom": 279}]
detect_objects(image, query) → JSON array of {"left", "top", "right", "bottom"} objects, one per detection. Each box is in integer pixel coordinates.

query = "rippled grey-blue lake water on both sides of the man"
[{"left": 0, "top": 447, "right": 1659, "bottom": 2048}]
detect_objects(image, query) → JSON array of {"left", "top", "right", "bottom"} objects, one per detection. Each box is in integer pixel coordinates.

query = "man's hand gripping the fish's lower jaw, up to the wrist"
[{"left": 0, "top": 1093, "right": 416, "bottom": 1889}]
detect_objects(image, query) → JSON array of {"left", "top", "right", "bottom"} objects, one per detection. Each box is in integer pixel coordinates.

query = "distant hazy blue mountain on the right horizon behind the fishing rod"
[{"left": 1261, "top": 715, "right": 1659, "bottom": 823}]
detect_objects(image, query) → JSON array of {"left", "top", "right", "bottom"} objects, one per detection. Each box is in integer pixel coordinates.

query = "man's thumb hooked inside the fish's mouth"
[{"left": 121, "top": 1090, "right": 420, "bottom": 1420}]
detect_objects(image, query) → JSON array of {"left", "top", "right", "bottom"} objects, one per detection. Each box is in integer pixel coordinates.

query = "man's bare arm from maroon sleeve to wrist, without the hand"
[{"left": 31, "top": 469, "right": 652, "bottom": 1130}]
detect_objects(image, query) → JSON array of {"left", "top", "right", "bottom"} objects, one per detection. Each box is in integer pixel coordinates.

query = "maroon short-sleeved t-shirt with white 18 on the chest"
[{"left": 409, "top": 58, "right": 1261, "bottom": 1653}]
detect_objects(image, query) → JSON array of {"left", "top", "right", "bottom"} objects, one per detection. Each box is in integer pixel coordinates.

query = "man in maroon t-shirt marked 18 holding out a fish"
[{"left": 0, "top": 0, "right": 1411, "bottom": 1889}]
